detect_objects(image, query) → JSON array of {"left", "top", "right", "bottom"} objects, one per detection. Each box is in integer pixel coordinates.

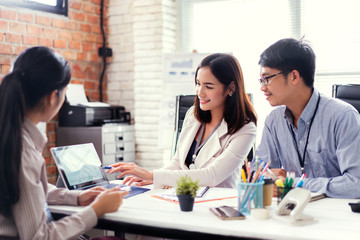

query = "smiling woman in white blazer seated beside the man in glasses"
[{"left": 107, "top": 53, "right": 256, "bottom": 188}]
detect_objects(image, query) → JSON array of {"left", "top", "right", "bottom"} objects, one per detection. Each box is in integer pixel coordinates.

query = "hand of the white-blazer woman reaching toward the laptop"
[{"left": 106, "top": 163, "right": 153, "bottom": 181}]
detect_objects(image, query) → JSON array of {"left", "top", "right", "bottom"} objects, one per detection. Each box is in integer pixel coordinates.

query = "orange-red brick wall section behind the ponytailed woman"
[{"left": 0, "top": 0, "right": 111, "bottom": 183}]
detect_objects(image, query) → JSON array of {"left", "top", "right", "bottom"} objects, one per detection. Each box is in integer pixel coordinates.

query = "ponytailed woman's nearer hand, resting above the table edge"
[{"left": 90, "top": 186, "right": 128, "bottom": 217}]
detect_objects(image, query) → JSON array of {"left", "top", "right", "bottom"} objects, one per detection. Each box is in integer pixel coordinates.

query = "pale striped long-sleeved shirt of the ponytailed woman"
[{"left": 0, "top": 119, "right": 97, "bottom": 239}]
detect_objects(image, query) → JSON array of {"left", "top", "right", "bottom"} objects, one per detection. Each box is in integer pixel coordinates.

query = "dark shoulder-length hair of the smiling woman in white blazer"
[{"left": 194, "top": 53, "right": 257, "bottom": 134}]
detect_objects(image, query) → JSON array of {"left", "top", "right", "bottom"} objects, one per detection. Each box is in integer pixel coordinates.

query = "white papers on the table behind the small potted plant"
[{"left": 151, "top": 187, "right": 237, "bottom": 203}]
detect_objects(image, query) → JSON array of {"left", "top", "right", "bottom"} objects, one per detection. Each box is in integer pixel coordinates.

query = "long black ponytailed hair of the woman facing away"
[{"left": 0, "top": 47, "right": 71, "bottom": 217}]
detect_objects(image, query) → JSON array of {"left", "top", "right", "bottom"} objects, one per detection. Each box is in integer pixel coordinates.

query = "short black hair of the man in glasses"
[{"left": 259, "top": 38, "right": 316, "bottom": 88}]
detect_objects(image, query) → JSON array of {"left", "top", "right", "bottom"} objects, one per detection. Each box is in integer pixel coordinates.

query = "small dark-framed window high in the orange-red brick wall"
[{"left": 1, "top": 0, "right": 68, "bottom": 16}]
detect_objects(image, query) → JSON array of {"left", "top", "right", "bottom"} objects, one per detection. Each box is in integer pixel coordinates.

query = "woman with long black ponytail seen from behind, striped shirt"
[{"left": 0, "top": 47, "right": 125, "bottom": 239}]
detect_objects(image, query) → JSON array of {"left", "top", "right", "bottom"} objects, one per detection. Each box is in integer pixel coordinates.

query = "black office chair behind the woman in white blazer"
[{"left": 172, "top": 93, "right": 254, "bottom": 161}]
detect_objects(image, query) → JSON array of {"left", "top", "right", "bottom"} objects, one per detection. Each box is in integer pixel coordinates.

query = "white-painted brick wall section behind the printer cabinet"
[{"left": 107, "top": 0, "right": 177, "bottom": 169}]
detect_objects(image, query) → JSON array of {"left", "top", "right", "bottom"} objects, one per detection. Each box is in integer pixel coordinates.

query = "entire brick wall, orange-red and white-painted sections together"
[{"left": 0, "top": 0, "right": 176, "bottom": 182}]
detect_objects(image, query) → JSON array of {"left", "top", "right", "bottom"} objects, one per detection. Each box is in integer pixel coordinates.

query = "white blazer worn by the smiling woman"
[{"left": 153, "top": 107, "right": 256, "bottom": 188}]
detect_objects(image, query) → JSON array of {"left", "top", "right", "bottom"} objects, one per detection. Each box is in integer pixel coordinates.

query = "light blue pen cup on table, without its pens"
[{"left": 238, "top": 181, "right": 264, "bottom": 215}]
